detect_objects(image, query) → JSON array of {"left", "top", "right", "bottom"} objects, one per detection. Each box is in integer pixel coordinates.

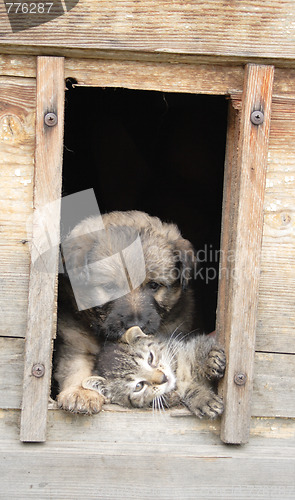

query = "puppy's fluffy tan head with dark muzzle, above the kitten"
[{"left": 63, "top": 213, "right": 194, "bottom": 339}]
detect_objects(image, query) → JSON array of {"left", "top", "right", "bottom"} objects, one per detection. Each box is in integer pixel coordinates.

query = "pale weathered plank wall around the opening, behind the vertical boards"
[{"left": 0, "top": 51, "right": 295, "bottom": 499}]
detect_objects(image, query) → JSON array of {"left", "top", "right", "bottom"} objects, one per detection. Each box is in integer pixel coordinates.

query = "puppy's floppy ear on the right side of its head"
[{"left": 173, "top": 238, "right": 197, "bottom": 290}]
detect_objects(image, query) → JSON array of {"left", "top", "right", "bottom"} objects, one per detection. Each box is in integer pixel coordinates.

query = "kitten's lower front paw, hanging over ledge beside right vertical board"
[{"left": 182, "top": 385, "right": 224, "bottom": 419}]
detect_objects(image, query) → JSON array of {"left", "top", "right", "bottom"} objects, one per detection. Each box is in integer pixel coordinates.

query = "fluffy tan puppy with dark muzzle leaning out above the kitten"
[{"left": 55, "top": 211, "right": 195, "bottom": 414}]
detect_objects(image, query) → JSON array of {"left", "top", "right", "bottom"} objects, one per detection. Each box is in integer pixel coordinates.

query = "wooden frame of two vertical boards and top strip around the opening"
[{"left": 20, "top": 56, "right": 274, "bottom": 443}]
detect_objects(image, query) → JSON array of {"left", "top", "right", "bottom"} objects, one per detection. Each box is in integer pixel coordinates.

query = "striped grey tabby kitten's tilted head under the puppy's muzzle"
[{"left": 82, "top": 327, "right": 176, "bottom": 408}]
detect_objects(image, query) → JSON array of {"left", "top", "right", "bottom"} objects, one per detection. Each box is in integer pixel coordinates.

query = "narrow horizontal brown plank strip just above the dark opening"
[{"left": 0, "top": 56, "right": 295, "bottom": 98}]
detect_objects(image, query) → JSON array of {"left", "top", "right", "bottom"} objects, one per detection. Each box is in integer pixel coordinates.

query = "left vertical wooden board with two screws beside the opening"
[{"left": 20, "top": 57, "right": 64, "bottom": 442}]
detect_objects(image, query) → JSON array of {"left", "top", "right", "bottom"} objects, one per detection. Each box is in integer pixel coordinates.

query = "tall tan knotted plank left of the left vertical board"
[{"left": 0, "top": 77, "right": 36, "bottom": 337}]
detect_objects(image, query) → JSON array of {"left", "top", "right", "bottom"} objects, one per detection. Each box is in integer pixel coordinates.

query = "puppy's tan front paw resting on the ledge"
[{"left": 57, "top": 387, "right": 104, "bottom": 415}]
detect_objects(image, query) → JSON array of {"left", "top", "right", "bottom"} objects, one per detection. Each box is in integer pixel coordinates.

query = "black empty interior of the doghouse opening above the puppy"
[{"left": 63, "top": 83, "right": 227, "bottom": 332}]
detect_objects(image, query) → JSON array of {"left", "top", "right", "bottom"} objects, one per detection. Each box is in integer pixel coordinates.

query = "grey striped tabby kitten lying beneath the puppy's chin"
[{"left": 82, "top": 327, "right": 225, "bottom": 418}]
